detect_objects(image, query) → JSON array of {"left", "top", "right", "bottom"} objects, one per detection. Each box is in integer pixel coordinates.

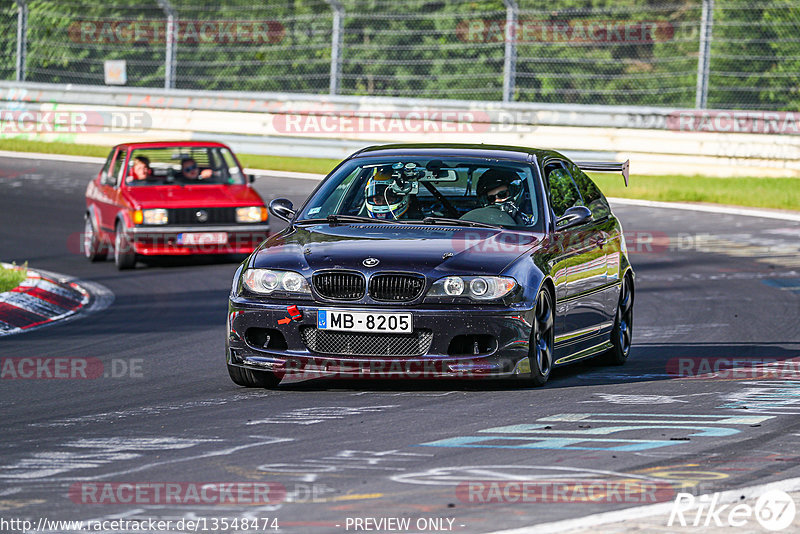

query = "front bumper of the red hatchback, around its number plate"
[{"left": 128, "top": 224, "right": 269, "bottom": 256}]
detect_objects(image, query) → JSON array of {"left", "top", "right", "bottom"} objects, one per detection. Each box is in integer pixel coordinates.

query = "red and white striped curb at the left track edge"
[{"left": 0, "top": 263, "right": 113, "bottom": 336}]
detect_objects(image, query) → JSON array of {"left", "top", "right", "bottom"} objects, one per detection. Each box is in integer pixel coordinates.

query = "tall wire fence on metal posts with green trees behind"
[{"left": 0, "top": 0, "right": 800, "bottom": 111}]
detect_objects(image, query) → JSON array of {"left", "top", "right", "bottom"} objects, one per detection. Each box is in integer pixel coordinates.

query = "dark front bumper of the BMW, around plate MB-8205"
[{"left": 226, "top": 297, "right": 533, "bottom": 378}]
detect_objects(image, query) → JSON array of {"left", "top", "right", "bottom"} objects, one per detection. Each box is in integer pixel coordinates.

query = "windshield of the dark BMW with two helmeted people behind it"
[{"left": 298, "top": 156, "right": 540, "bottom": 228}]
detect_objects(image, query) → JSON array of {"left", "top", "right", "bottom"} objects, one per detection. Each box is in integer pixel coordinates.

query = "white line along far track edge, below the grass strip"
[{"left": 0, "top": 150, "right": 800, "bottom": 222}]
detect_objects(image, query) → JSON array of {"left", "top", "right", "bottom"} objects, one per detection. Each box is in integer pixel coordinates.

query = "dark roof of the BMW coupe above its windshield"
[{"left": 352, "top": 143, "right": 563, "bottom": 161}]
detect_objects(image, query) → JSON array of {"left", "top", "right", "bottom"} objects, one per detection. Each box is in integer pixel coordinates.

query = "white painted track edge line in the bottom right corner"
[{"left": 491, "top": 478, "right": 800, "bottom": 534}]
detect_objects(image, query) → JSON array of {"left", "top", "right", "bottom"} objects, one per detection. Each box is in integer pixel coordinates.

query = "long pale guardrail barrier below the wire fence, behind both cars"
[{"left": 0, "top": 82, "right": 800, "bottom": 176}]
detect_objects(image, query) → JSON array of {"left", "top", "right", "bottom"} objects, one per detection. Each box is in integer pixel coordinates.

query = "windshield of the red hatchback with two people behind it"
[{"left": 125, "top": 146, "right": 247, "bottom": 187}]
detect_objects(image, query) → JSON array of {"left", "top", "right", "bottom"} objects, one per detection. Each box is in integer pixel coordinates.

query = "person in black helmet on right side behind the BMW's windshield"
[{"left": 461, "top": 168, "right": 520, "bottom": 226}]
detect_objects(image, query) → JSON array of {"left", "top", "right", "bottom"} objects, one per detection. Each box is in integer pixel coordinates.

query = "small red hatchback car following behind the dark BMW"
[{"left": 83, "top": 141, "right": 269, "bottom": 269}]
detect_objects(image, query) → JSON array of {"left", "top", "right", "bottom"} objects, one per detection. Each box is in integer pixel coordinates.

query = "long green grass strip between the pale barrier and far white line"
[{"left": 2, "top": 139, "right": 800, "bottom": 210}]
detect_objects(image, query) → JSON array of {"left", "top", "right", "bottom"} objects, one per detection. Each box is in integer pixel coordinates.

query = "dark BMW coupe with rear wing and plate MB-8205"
[{"left": 226, "top": 144, "right": 634, "bottom": 387}]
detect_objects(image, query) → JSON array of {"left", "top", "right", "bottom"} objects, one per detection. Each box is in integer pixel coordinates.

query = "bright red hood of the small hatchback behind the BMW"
[{"left": 124, "top": 184, "right": 264, "bottom": 209}]
